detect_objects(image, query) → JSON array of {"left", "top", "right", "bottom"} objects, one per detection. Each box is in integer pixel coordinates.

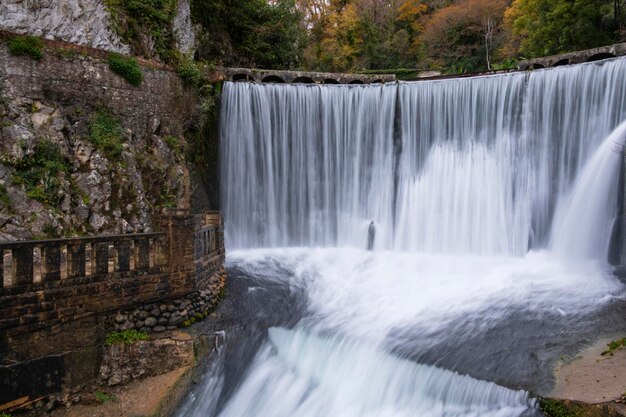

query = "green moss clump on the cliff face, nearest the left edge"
[{"left": 13, "top": 140, "right": 70, "bottom": 207}]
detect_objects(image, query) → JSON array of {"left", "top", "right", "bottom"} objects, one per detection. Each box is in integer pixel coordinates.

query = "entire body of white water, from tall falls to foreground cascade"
[{"left": 176, "top": 59, "right": 626, "bottom": 417}]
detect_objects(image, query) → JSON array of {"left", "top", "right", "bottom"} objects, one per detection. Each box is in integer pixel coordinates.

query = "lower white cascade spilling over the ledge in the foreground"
[{"left": 214, "top": 328, "right": 532, "bottom": 417}]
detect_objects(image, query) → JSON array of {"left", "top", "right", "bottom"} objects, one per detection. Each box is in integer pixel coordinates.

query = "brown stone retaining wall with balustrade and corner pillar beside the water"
[{"left": 0, "top": 211, "right": 225, "bottom": 409}]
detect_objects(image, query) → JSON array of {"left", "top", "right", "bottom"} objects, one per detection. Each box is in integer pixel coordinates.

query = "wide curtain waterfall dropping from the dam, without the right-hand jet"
[{"left": 220, "top": 59, "right": 626, "bottom": 256}]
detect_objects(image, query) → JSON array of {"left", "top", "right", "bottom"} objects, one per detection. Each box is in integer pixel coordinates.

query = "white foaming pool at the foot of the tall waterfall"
[{"left": 229, "top": 248, "right": 624, "bottom": 342}]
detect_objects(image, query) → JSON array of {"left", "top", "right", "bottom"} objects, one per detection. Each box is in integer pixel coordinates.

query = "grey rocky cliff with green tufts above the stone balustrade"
[{"left": 0, "top": 39, "right": 195, "bottom": 241}]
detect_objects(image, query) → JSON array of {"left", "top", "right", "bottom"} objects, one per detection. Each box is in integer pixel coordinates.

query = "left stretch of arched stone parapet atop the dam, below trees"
[{"left": 210, "top": 67, "right": 396, "bottom": 84}]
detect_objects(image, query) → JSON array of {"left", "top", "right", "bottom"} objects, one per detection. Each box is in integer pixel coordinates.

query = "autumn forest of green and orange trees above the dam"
[{"left": 192, "top": 0, "right": 626, "bottom": 73}]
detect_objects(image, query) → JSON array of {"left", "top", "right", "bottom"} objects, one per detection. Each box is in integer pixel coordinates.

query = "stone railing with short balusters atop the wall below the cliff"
[{"left": 0, "top": 233, "right": 167, "bottom": 288}]
